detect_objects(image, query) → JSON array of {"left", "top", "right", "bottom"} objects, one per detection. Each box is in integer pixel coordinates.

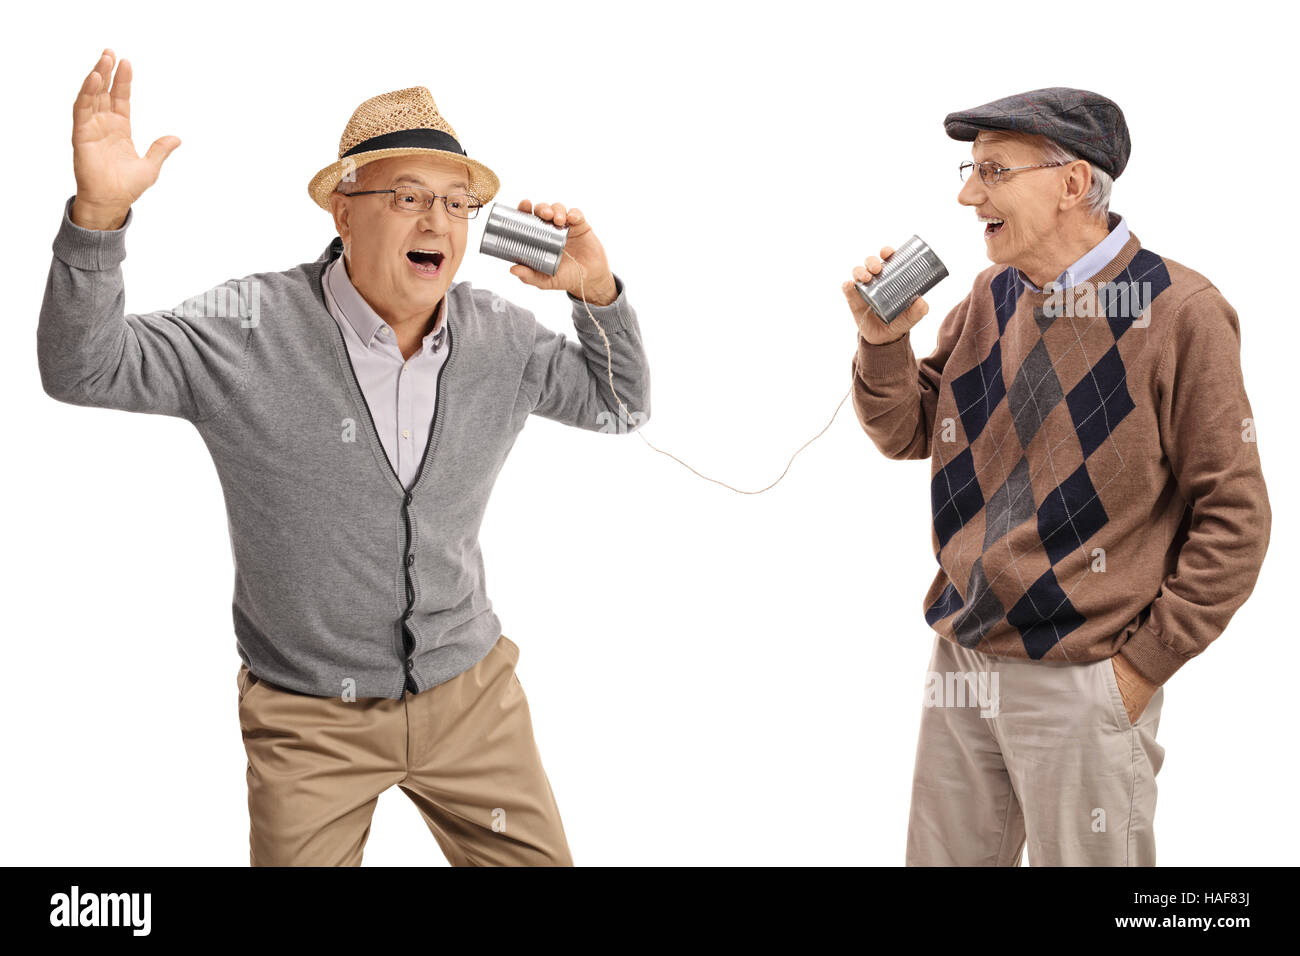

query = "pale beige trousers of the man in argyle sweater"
[{"left": 907, "top": 636, "right": 1165, "bottom": 866}]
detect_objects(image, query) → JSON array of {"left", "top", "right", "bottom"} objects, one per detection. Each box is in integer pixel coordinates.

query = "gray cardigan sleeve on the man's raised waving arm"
[{"left": 36, "top": 196, "right": 260, "bottom": 423}]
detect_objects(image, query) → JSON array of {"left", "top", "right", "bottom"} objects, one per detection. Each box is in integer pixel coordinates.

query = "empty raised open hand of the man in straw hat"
[{"left": 70, "top": 49, "right": 181, "bottom": 229}]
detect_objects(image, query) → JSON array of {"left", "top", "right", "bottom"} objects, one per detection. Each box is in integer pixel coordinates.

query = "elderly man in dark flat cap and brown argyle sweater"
[{"left": 844, "top": 87, "right": 1270, "bottom": 866}]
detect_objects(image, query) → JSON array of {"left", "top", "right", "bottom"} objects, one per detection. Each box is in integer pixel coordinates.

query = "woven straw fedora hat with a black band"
[{"left": 307, "top": 86, "right": 501, "bottom": 212}]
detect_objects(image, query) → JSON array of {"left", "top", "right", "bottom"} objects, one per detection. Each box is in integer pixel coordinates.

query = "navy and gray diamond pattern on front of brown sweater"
[{"left": 926, "top": 250, "right": 1170, "bottom": 659}]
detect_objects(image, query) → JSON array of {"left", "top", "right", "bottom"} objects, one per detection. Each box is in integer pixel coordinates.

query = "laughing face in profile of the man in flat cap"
[{"left": 957, "top": 130, "right": 1087, "bottom": 278}]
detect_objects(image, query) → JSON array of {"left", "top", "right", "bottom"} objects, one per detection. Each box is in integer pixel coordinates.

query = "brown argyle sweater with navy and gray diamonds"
[{"left": 853, "top": 227, "right": 1271, "bottom": 684}]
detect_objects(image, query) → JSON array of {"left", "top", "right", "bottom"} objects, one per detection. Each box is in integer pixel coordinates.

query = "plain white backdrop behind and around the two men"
[{"left": 0, "top": 3, "right": 1300, "bottom": 866}]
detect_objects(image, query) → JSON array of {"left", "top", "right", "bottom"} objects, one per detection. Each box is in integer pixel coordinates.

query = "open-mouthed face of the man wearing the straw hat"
[{"left": 330, "top": 156, "right": 469, "bottom": 326}]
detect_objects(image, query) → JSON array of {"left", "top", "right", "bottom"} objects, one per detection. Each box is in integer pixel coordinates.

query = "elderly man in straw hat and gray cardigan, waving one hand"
[{"left": 38, "top": 51, "right": 650, "bottom": 865}]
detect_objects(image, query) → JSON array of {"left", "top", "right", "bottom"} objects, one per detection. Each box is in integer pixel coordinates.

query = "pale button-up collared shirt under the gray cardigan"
[{"left": 321, "top": 256, "right": 447, "bottom": 489}]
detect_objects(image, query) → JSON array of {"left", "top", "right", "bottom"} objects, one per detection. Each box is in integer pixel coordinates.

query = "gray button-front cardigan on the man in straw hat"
[{"left": 36, "top": 199, "right": 650, "bottom": 698}]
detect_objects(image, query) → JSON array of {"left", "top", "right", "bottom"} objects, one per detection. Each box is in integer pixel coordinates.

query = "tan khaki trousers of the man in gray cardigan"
[{"left": 239, "top": 635, "right": 573, "bottom": 866}]
